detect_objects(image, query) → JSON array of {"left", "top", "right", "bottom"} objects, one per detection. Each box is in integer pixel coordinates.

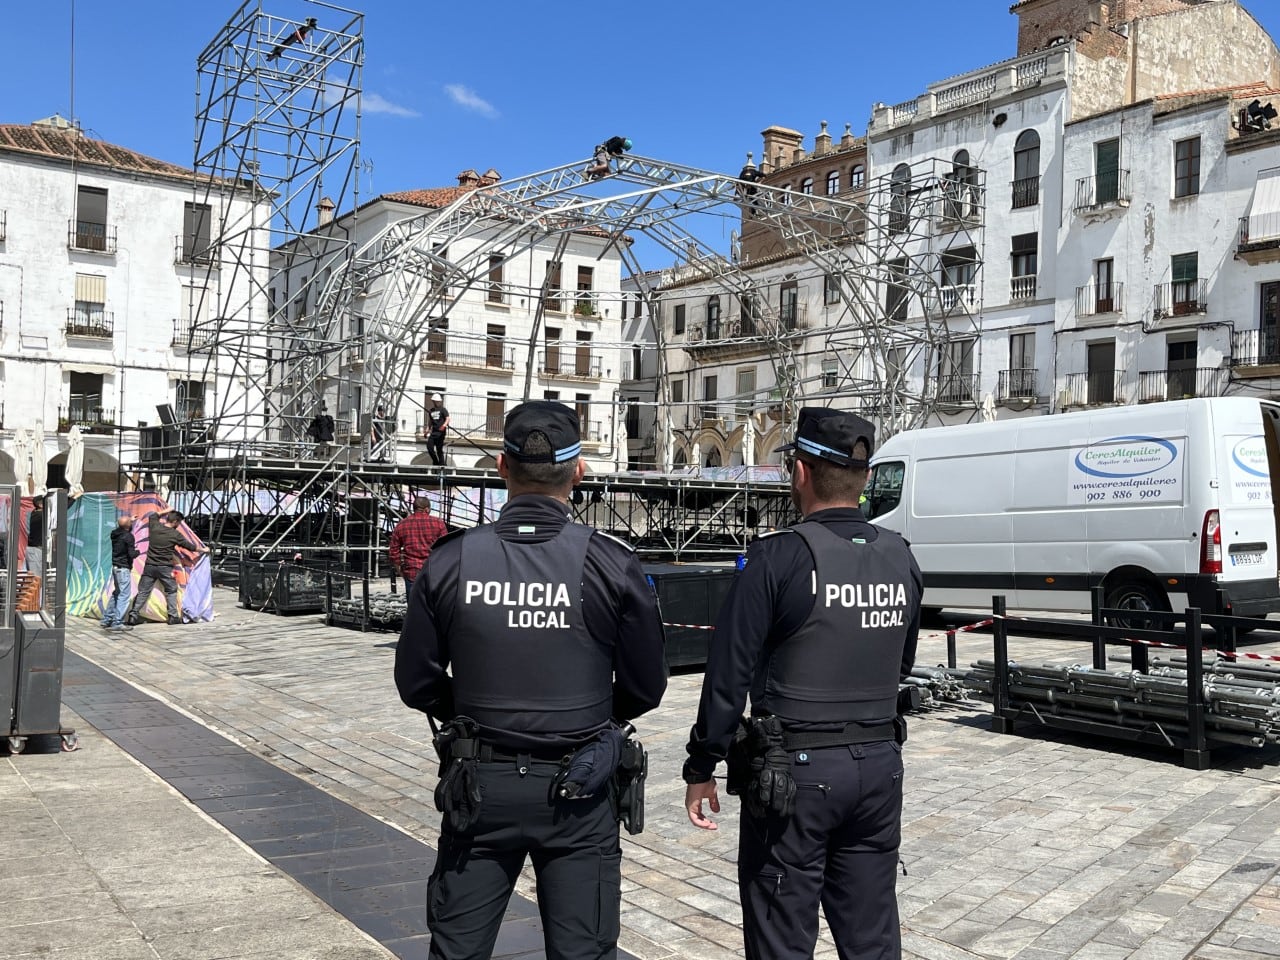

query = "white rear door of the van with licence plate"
[{"left": 1201, "top": 403, "right": 1280, "bottom": 614}]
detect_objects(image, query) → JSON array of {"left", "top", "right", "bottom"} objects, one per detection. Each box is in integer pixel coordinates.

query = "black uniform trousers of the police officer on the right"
[{"left": 737, "top": 741, "right": 902, "bottom": 960}]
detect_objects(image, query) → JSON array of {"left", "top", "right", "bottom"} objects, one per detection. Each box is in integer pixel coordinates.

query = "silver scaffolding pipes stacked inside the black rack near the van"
[{"left": 963, "top": 657, "right": 1280, "bottom": 746}]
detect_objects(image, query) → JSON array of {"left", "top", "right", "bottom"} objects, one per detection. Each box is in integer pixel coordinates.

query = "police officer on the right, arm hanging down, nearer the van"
[{"left": 684, "top": 407, "right": 922, "bottom": 960}]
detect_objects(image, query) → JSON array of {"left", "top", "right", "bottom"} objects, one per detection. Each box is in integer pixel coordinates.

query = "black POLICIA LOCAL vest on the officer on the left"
[{"left": 448, "top": 524, "right": 614, "bottom": 735}]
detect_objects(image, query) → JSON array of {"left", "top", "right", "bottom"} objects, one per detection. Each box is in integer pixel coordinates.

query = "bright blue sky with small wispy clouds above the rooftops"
[{"left": 0, "top": 0, "right": 1280, "bottom": 245}]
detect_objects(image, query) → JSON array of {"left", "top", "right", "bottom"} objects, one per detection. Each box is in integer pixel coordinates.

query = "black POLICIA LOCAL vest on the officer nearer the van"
[{"left": 751, "top": 524, "right": 920, "bottom": 723}]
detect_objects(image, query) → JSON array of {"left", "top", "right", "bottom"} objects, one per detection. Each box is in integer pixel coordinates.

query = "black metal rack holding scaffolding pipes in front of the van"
[{"left": 966, "top": 589, "right": 1280, "bottom": 769}]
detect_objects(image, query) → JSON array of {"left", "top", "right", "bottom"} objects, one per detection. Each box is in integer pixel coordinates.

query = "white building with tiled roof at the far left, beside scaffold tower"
[{"left": 0, "top": 118, "right": 266, "bottom": 490}]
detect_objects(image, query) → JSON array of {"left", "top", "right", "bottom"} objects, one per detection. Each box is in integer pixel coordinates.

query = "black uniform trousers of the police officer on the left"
[{"left": 426, "top": 760, "right": 622, "bottom": 960}]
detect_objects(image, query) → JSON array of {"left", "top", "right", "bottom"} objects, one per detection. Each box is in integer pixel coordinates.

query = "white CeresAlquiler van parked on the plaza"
[{"left": 864, "top": 397, "right": 1280, "bottom": 617}]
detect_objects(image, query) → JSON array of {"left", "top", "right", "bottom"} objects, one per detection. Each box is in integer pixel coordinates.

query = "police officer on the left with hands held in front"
[{"left": 396, "top": 401, "right": 667, "bottom": 960}]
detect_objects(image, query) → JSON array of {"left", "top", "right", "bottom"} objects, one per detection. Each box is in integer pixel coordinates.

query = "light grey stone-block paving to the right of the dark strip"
[{"left": 68, "top": 589, "right": 1280, "bottom": 960}]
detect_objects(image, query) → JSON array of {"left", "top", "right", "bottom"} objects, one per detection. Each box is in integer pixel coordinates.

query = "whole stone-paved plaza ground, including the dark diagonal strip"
[{"left": 0, "top": 589, "right": 1280, "bottom": 960}]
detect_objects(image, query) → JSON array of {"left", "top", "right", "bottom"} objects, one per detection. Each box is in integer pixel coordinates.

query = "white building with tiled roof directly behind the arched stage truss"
[{"left": 271, "top": 170, "right": 631, "bottom": 472}]
